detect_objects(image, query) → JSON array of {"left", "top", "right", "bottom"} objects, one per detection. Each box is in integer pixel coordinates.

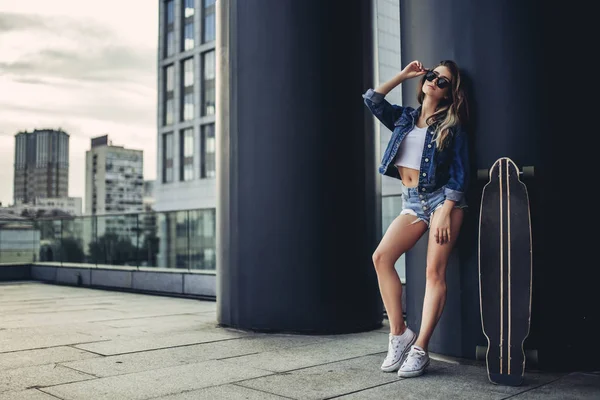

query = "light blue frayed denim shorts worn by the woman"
[{"left": 400, "top": 185, "right": 467, "bottom": 227}]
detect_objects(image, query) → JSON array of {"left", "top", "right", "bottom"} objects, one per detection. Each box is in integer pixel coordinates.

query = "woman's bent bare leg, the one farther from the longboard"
[{"left": 373, "top": 214, "right": 427, "bottom": 335}]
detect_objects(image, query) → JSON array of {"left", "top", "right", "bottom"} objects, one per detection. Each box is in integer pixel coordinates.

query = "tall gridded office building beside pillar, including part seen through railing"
[{"left": 154, "top": 0, "right": 216, "bottom": 269}]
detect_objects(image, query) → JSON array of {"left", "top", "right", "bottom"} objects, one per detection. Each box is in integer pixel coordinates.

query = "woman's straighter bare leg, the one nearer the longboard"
[{"left": 415, "top": 208, "right": 464, "bottom": 351}]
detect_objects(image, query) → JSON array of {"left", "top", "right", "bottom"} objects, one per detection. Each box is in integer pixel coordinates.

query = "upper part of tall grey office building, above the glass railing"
[{"left": 155, "top": 0, "right": 216, "bottom": 211}]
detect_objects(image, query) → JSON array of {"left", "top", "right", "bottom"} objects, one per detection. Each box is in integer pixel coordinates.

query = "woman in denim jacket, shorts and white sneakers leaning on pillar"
[{"left": 363, "top": 60, "right": 469, "bottom": 378}]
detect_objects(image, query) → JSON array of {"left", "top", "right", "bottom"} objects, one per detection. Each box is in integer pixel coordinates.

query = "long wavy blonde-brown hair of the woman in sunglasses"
[{"left": 417, "top": 60, "right": 469, "bottom": 150}]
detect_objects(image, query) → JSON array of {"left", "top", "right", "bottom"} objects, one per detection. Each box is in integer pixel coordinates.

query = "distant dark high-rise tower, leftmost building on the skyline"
[{"left": 14, "top": 129, "right": 69, "bottom": 204}]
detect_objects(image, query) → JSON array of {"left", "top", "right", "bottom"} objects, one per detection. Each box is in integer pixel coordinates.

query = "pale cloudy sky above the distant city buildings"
[{"left": 0, "top": 0, "right": 158, "bottom": 205}]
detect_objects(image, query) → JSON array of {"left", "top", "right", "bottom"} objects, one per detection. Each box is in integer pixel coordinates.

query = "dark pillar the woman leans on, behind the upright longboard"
[{"left": 400, "top": 0, "right": 600, "bottom": 370}]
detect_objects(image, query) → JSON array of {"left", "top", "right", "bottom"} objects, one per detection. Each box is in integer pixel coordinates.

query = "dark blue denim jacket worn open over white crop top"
[{"left": 363, "top": 89, "right": 469, "bottom": 202}]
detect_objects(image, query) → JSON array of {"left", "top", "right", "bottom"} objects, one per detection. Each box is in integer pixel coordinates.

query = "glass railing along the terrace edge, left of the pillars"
[{"left": 0, "top": 208, "right": 216, "bottom": 270}]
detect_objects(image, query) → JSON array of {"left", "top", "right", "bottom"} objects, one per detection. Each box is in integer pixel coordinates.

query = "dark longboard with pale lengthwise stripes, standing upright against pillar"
[{"left": 478, "top": 157, "right": 533, "bottom": 386}]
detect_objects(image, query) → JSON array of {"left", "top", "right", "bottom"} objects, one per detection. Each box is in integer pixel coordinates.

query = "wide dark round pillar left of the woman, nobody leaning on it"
[{"left": 216, "top": 0, "right": 383, "bottom": 333}]
